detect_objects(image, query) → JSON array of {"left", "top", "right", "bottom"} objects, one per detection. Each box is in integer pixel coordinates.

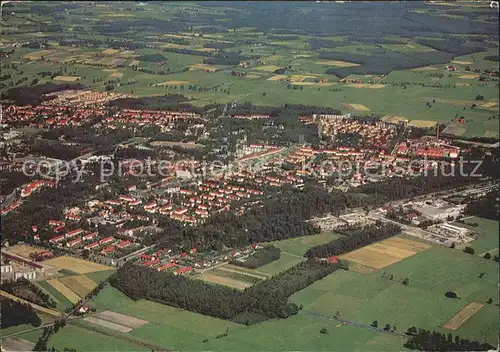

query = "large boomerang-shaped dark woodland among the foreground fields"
[{"left": 110, "top": 260, "right": 339, "bottom": 324}]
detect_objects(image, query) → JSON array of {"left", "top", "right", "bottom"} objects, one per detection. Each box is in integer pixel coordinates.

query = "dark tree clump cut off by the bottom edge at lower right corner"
[{"left": 404, "top": 327, "right": 496, "bottom": 351}]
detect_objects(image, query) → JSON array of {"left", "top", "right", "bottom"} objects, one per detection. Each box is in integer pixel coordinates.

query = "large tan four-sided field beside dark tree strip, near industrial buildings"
[{"left": 340, "top": 237, "right": 431, "bottom": 269}]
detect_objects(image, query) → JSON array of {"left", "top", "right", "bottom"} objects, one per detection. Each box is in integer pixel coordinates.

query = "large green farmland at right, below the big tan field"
[{"left": 291, "top": 247, "right": 498, "bottom": 343}]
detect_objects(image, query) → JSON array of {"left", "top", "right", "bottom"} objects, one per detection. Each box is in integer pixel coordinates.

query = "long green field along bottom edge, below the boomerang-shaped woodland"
[{"left": 49, "top": 286, "right": 404, "bottom": 351}]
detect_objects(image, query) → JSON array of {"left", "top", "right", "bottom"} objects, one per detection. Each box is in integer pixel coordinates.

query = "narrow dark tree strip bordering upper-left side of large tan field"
[{"left": 305, "top": 220, "right": 401, "bottom": 258}]
